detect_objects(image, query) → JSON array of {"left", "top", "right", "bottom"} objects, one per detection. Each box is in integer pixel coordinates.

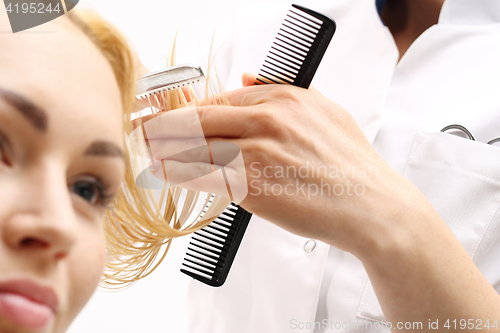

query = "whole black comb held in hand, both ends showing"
[{"left": 181, "top": 5, "right": 335, "bottom": 287}]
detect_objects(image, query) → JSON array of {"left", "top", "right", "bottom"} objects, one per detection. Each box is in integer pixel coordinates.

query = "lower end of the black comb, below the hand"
[{"left": 181, "top": 195, "right": 252, "bottom": 287}]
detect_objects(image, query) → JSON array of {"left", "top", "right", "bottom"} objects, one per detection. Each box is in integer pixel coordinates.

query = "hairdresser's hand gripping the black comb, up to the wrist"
[{"left": 134, "top": 71, "right": 426, "bottom": 253}]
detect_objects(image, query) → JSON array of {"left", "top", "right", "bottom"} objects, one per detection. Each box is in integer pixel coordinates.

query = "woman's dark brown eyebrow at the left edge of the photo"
[{"left": 0, "top": 88, "right": 49, "bottom": 132}]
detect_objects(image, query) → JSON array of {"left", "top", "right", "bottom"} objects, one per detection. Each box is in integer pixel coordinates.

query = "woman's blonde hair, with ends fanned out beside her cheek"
[{"left": 68, "top": 10, "right": 230, "bottom": 288}]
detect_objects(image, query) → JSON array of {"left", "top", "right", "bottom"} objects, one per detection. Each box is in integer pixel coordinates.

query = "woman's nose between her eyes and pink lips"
[{"left": 0, "top": 166, "right": 78, "bottom": 260}]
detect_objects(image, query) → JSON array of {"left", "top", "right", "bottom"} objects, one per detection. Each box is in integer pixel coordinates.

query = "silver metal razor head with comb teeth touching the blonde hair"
[{"left": 135, "top": 64, "right": 205, "bottom": 99}]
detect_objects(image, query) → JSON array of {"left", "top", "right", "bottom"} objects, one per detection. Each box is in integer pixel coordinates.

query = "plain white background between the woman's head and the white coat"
[{"left": 68, "top": 0, "right": 286, "bottom": 333}]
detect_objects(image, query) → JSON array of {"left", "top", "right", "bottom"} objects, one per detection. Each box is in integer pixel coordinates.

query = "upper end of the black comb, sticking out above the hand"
[{"left": 257, "top": 5, "right": 336, "bottom": 88}]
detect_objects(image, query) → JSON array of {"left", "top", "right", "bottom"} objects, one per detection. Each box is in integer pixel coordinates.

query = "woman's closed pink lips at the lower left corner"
[{"left": 0, "top": 280, "right": 59, "bottom": 329}]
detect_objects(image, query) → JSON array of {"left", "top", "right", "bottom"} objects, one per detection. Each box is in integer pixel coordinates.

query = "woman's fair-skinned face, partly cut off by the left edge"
[{"left": 0, "top": 16, "right": 125, "bottom": 333}]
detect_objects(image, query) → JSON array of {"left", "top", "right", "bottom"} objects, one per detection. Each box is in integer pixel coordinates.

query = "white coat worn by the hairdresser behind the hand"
[{"left": 188, "top": 0, "right": 500, "bottom": 333}]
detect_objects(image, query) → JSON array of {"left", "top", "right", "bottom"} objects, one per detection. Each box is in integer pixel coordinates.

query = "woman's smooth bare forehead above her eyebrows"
[{"left": 0, "top": 16, "right": 122, "bottom": 141}]
